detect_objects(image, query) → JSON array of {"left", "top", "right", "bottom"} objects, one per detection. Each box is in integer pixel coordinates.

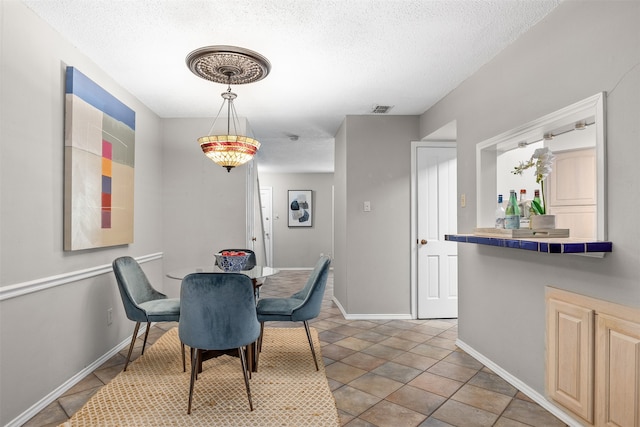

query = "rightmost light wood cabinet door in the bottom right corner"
[{"left": 596, "top": 313, "right": 640, "bottom": 427}]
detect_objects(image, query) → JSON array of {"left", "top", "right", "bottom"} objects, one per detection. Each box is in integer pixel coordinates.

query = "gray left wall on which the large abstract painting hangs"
[{"left": 0, "top": 0, "right": 163, "bottom": 425}]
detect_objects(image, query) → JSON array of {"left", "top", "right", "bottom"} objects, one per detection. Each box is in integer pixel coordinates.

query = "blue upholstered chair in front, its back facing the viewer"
[{"left": 178, "top": 273, "right": 260, "bottom": 414}]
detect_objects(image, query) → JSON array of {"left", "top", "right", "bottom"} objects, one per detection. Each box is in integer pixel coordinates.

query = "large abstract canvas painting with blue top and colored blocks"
[{"left": 64, "top": 67, "right": 136, "bottom": 251}]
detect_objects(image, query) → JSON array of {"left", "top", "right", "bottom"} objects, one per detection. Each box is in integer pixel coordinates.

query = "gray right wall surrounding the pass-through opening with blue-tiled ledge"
[{"left": 420, "top": 1, "right": 640, "bottom": 400}]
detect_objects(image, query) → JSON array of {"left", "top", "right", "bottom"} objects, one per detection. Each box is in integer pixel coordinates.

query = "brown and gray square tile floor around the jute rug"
[{"left": 25, "top": 270, "right": 565, "bottom": 427}]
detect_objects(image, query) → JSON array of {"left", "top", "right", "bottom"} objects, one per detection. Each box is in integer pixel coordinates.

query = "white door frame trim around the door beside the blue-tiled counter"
[{"left": 409, "top": 141, "right": 458, "bottom": 319}]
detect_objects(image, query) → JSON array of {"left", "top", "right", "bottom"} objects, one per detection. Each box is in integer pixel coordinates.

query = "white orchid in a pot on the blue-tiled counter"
[{"left": 511, "top": 147, "right": 556, "bottom": 230}]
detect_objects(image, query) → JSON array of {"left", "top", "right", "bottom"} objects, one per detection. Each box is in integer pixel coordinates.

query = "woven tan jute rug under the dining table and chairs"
[{"left": 61, "top": 328, "right": 340, "bottom": 427}]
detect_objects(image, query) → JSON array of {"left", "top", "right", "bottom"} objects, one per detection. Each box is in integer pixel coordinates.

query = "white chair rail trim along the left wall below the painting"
[{"left": 0, "top": 252, "right": 163, "bottom": 301}]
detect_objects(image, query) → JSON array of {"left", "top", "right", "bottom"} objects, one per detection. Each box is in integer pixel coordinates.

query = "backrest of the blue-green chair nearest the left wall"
[{"left": 112, "top": 256, "right": 167, "bottom": 322}]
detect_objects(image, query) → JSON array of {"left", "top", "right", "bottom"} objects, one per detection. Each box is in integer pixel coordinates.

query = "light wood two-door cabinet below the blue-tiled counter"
[{"left": 546, "top": 287, "right": 640, "bottom": 427}]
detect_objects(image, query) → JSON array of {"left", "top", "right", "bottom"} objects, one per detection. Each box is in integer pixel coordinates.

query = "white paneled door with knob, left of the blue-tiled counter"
[{"left": 415, "top": 146, "right": 458, "bottom": 319}]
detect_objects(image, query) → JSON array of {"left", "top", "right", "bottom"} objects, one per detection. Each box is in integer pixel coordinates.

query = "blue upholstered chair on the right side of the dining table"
[{"left": 256, "top": 256, "right": 331, "bottom": 371}]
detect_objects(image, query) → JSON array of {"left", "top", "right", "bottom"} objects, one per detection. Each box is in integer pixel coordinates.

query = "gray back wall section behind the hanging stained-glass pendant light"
[{"left": 158, "top": 119, "right": 250, "bottom": 296}]
